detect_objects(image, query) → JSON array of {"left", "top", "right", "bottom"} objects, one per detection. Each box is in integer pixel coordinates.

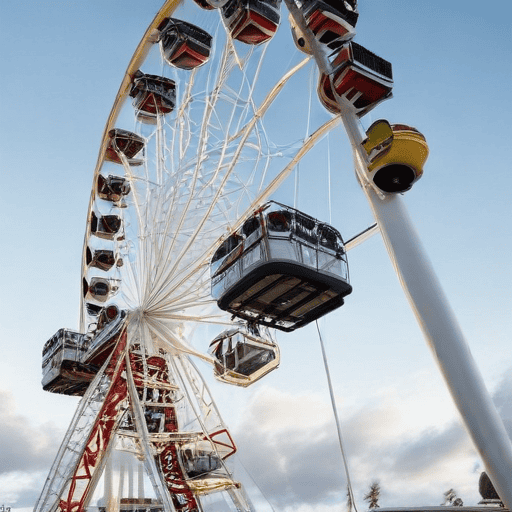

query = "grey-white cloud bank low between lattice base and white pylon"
[{"left": 233, "top": 370, "right": 512, "bottom": 512}]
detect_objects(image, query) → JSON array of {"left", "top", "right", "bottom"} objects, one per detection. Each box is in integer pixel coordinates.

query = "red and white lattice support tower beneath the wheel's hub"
[{"left": 35, "top": 329, "right": 251, "bottom": 512}]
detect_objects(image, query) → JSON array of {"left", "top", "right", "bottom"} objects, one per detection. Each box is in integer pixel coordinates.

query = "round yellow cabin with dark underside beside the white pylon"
[{"left": 362, "top": 119, "right": 429, "bottom": 194}]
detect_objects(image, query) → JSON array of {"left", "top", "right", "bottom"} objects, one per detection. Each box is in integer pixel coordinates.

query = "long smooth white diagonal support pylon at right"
[{"left": 285, "top": 0, "right": 512, "bottom": 504}]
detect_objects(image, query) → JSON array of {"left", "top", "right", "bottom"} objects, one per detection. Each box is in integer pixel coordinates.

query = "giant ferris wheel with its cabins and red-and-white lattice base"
[{"left": 35, "top": 0, "right": 512, "bottom": 512}]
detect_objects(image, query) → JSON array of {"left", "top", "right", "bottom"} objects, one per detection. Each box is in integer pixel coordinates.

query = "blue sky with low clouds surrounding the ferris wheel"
[{"left": 0, "top": 0, "right": 512, "bottom": 512}]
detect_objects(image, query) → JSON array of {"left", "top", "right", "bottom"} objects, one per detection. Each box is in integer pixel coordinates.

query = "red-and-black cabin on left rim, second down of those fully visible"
[{"left": 130, "top": 71, "right": 176, "bottom": 124}]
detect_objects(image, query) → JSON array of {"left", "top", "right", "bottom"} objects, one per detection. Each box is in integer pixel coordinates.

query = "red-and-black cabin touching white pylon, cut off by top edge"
[{"left": 296, "top": 0, "right": 359, "bottom": 50}]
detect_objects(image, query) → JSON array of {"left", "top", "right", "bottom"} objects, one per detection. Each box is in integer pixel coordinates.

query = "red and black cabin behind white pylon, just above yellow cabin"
[{"left": 318, "top": 42, "right": 393, "bottom": 117}]
